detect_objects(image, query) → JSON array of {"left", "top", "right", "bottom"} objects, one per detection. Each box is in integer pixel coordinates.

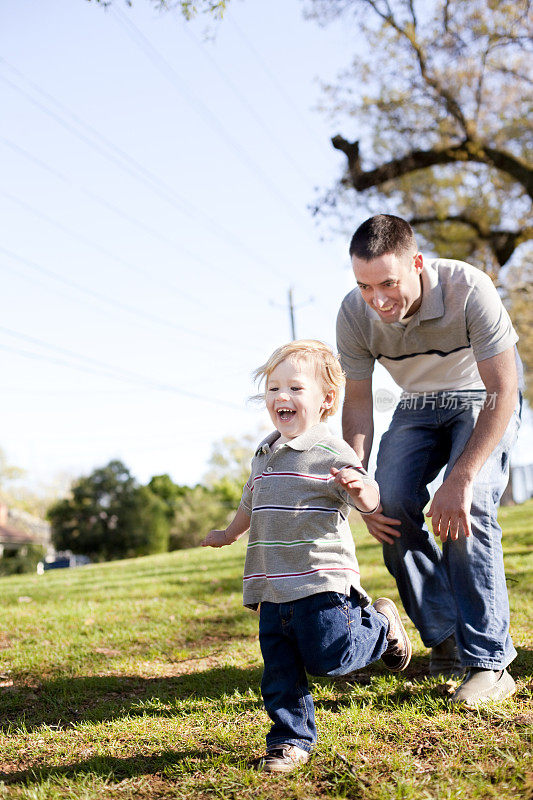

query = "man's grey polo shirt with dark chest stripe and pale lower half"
[{"left": 337, "top": 258, "right": 518, "bottom": 393}]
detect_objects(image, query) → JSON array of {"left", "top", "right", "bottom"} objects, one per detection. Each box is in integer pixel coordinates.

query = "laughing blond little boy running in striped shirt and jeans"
[{"left": 202, "top": 340, "right": 411, "bottom": 772}]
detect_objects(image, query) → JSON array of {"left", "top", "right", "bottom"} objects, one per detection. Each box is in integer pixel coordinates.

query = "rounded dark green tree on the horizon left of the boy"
[{"left": 48, "top": 461, "right": 169, "bottom": 560}]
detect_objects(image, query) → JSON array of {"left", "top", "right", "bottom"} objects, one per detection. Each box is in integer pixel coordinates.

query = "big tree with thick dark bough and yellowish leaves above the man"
[{"left": 307, "top": 0, "right": 533, "bottom": 274}]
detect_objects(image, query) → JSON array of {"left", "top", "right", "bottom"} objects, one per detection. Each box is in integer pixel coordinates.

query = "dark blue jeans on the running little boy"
[{"left": 259, "top": 592, "right": 389, "bottom": 752}]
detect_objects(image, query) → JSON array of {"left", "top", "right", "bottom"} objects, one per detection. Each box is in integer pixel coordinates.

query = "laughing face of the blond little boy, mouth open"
[{"left": 266, "top": 358, "right": 335, "bottom": 439}]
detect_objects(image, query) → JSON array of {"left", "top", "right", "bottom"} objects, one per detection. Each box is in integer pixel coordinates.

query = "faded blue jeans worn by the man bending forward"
[{"left": 376, "top": 391, "right": 520, "bottom": 669}]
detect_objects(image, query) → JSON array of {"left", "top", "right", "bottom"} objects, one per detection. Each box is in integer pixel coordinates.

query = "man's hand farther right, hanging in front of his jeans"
[{"left": 428, "top": 478, "right": 473, "bottom": 542}]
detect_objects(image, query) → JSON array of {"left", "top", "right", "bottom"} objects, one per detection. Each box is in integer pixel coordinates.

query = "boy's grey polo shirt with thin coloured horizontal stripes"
[{"left": 240, "top": 423, "right": 377, "bottom": 608}]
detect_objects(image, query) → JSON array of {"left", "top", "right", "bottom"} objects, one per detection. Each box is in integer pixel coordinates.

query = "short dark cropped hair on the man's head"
[{"left": 350, "top": 214, "right": 418, "bottom": 261}]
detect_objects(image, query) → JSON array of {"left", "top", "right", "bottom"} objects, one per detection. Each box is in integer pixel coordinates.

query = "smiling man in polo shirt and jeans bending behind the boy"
[{"left": 337, "top": 215, "right": 520, "bottom": 707}]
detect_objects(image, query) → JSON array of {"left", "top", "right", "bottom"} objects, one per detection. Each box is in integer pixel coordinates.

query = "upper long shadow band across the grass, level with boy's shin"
[{"left": 0, "top": 636, "right": 533, "bottom": 732}]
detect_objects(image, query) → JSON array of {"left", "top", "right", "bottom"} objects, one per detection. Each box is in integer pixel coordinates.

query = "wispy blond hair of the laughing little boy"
[{"left": 253, "top": 339, "right": 346, "bottom": 419}]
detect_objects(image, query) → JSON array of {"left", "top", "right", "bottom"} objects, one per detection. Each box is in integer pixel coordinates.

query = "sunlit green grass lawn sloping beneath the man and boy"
[{"left": 0, "top": 501, "right": 533, "bottom": 800}]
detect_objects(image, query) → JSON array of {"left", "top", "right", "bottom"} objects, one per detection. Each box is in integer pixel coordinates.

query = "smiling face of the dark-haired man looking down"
[{"left": 352, "top": 253, "right": 424, "bottom": 322}]
